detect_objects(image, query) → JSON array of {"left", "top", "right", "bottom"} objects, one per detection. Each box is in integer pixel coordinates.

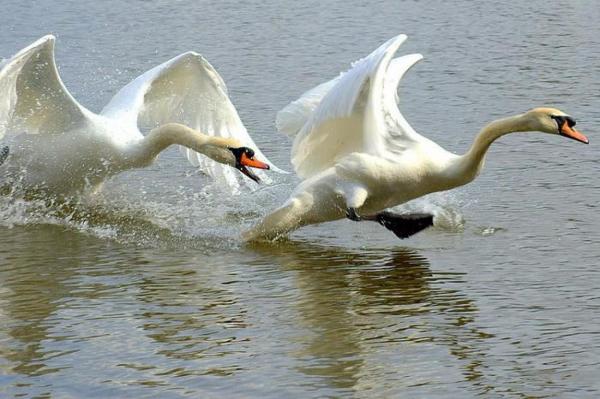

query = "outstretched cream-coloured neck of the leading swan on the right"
[{"left": 452, "top": 115, "right": 533, "bottom": 185}]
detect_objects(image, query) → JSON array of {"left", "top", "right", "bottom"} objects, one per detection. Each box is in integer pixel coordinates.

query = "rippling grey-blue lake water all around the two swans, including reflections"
[{"left": 0, "top": 0, "right": 600, "bottom": 398}]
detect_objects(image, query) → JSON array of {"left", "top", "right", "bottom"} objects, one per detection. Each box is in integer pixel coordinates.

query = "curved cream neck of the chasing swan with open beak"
[{"left": 134, "top": 123, "right": 230, "bottom": 165}]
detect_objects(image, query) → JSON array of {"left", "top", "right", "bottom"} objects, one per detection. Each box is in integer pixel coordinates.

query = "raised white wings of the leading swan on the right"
[{"left": 278, "top": 35, "right": 427, "bottom": 178}]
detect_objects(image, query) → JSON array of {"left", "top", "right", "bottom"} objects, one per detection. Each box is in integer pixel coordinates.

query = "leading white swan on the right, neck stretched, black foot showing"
[{"left": 243, "top": 35, "right": 588, "bottom": 241}]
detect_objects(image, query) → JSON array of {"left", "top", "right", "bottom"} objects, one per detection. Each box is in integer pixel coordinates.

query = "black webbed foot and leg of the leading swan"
[{"left": 346, "top": 208, "right": 433, "bottom": 238}]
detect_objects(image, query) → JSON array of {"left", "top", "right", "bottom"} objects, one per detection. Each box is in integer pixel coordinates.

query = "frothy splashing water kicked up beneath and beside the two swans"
[{"left": 0, "top": 170, "right": 472, "bottom": 245}]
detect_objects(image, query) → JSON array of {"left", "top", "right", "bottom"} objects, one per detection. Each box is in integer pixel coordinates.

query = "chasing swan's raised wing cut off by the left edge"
[{"left": 0, "top": 35, "right": 91, "bottom": 138}]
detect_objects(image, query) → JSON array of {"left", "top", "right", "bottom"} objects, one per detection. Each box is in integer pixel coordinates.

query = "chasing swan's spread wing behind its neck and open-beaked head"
[{"left": 102, "top": 52, "right": 280, "bottom": 187}]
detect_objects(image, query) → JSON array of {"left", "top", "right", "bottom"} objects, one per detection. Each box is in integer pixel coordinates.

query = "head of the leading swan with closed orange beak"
[{"left": 524, "top": 108, "right": 589, "bottom": 144}]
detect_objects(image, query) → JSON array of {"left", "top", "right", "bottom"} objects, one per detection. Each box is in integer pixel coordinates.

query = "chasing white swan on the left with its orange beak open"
[{"left": 0, "top": 35, "right": 279, "bottom": 195}]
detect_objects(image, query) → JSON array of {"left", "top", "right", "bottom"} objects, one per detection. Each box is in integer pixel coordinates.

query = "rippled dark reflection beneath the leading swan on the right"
[{"left": 246, "top": 241, "right": 490, "bottom": 394}]
